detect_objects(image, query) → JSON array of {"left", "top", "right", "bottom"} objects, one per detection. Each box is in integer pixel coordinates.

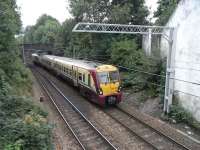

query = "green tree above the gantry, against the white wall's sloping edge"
[{"left": 154, "top": 0, "right": 180, "bottom": 25}]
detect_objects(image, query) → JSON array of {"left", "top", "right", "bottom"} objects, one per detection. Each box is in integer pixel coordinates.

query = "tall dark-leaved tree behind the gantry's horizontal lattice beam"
[{"left": 66, "top": 0, "right": 149, "bottom": 59}]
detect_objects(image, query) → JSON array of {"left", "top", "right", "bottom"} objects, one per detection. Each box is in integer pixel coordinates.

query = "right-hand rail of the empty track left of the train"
[{"left": 33, "top": 67, "right": 117, "bottom": 150}]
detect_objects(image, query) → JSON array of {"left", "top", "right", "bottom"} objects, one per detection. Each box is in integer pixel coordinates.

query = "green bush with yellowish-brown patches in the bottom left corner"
[{"left": 0, "top": 96, "right": 52, "bottom": 150}]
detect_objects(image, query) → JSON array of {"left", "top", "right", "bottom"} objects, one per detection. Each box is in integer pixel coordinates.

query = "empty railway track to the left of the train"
[{"left": 31, "top": 68, "right": 117, "bottom": 150}]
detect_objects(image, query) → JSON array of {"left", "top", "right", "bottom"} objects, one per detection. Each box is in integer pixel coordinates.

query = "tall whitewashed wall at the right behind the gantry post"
[{"left": 161, "top": 0, "right": 200, "bottom": 121}]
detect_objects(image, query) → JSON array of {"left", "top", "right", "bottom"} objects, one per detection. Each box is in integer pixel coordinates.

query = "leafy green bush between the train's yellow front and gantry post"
[{"left": 110, "top": 38, "right": 165, "bottom": 96}]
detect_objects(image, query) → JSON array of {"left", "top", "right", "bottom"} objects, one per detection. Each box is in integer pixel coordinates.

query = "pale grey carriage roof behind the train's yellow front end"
[{"left": 43, "top": 55, "right": 106, "bottom": 69}]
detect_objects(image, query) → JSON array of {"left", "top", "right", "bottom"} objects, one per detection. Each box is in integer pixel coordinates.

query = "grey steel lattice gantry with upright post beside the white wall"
[{"left": 72, "top": 23, "right": 177, "bottom": 113}]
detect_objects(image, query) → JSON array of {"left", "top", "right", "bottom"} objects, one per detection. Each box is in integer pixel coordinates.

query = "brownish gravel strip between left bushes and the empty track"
[{"left": 33, "top": 69, "right": 81, "bottom": 150}]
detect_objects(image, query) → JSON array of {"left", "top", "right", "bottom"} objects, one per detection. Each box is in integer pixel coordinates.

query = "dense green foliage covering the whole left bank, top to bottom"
[{"left": 0, "top": 0, "right": 51, "bottom": 150}]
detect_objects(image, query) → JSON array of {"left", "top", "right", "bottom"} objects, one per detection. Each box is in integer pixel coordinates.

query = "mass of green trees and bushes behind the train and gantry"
[{"left": 61, "top": 0, "right": 161, "bottom": 95}]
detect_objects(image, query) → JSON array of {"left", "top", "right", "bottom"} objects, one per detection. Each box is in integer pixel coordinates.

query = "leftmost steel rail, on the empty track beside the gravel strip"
[{"left": 32, "top": 70, "right": 86, "bottom": 150}]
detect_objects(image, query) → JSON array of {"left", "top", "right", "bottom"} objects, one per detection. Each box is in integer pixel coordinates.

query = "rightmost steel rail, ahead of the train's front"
[{"left": 116, "top": 107, "right": 191, "bottom": 150}]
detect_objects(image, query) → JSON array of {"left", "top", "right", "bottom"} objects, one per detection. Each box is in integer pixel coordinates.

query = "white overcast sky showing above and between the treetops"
[{"left": 17, "top": 0, "right": 157, "bottom": 27}]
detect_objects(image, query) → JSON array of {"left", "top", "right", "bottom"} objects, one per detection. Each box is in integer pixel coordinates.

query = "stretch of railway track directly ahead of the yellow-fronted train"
[{"left": 105, "top": 107, "right": 191, "bottom": 150}]
